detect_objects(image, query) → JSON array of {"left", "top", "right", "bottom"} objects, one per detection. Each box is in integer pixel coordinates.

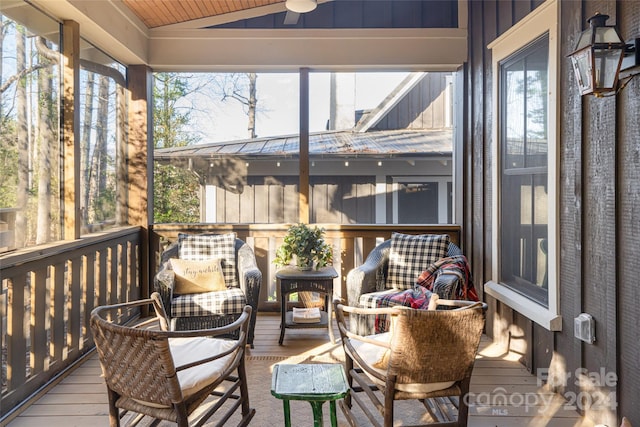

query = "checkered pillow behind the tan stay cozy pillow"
[{"left": 178, "top": 233, "right": 240, "bottom": 288}]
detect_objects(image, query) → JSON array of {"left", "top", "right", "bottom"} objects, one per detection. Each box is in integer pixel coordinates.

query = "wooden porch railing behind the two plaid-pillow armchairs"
[{"left": 150, "top": 224, "right": 460, "bottom": 311}]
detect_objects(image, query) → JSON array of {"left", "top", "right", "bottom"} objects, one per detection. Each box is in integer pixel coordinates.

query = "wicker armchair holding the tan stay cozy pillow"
[{"left": 153, "top": 238, "right": 262, "bottom": 348}]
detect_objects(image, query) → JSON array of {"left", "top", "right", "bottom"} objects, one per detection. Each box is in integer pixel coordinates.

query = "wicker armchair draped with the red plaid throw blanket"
[{"left": 347, "top": 239, "right": 462, "bottom": 335}]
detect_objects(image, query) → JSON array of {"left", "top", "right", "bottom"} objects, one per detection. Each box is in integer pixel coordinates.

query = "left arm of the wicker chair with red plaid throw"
[{"left": 347, "top": 240, "right": 391, "bottom": 307}]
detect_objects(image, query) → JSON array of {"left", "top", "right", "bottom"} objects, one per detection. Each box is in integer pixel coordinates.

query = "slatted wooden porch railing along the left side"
[{"left": 0, "top": 227, "right": 142, "bottom": 421}]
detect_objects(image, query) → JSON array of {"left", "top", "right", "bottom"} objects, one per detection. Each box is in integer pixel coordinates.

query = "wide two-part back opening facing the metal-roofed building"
[{"left": 154, "top": 71, "right": 453, "bottom": 224}]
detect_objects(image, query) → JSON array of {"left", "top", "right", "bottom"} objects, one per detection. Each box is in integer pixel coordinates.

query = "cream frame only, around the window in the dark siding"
[{"left": 484, "top": 0, "right": 562, "bottom": 331}]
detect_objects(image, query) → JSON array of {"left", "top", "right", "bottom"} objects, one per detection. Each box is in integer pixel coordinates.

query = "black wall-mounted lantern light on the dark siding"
[{"left": 569, "top": 13, "right": 640, "bottom": 97}]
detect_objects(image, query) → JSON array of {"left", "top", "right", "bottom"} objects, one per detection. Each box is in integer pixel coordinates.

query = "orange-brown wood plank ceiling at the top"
[{"left": 122, "top": 0, "right": 284, "bottom": 28}]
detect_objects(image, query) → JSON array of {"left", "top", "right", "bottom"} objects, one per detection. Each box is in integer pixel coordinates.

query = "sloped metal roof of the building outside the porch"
[{"left": 154, "top": 129, "right": 453, "bottom": 160}]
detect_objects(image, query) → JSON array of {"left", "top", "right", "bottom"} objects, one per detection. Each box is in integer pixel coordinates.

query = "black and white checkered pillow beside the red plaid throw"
[{"left": 387, "top": 233, "right": 449, "bottom": 289}]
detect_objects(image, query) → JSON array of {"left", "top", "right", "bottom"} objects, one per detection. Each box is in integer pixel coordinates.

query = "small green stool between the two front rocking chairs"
[{"left": 271, "top": 364, "right": 348, "bottom": 427}]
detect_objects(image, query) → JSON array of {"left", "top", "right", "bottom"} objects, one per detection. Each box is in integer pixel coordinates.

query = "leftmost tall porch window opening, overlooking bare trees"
[{"left": 0, "top": 8, "right": 62, "bottom": 253}]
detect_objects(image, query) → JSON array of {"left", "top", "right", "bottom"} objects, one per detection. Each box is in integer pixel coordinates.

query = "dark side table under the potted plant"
[{"left": 276, "top": 266, "right": 338, "bottom": 345}]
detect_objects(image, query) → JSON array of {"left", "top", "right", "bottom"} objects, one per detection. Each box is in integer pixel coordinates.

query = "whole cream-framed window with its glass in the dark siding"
[{"left": 485, "top": 1, "right": 562, "bottom": 330}]
